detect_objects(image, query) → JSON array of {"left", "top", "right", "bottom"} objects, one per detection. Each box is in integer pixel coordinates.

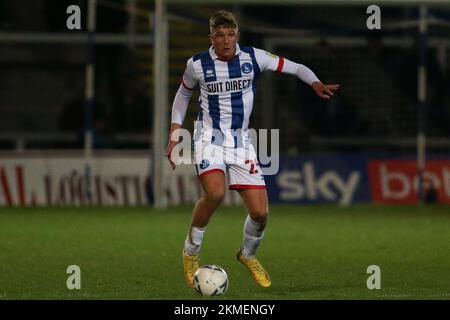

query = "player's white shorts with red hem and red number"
[{"left": 194, "top": 141, "right": 266, "bottom": 189}]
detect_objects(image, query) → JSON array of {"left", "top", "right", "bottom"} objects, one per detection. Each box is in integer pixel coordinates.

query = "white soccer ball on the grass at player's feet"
[{"left": 194, "top": 264, "right": 228, "bottom": 296}]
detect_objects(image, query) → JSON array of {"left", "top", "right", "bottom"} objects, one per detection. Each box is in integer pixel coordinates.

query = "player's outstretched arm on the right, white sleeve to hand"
[{"left": 254, "top": 48, "right": 339, "bottom": 99}]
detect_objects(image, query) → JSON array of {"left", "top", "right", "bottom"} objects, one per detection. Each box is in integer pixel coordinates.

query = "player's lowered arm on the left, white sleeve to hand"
[{"left": 166, "top": 58, "right": 198, "bottom": 170}]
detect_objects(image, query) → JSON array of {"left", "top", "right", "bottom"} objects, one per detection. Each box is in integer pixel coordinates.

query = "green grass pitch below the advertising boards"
[{"left": 0, "top": 205, "right": 450, "bottom": 299}]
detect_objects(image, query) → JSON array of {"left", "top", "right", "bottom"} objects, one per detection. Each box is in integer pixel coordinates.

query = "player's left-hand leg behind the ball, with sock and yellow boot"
[{"left": 183, "top": 168, "right": 225, "bottom": 287}]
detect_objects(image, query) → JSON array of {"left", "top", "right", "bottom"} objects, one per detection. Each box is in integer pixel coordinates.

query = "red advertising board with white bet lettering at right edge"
[{"left": 368, "top": 160, "right": 450, "bottom": 204}]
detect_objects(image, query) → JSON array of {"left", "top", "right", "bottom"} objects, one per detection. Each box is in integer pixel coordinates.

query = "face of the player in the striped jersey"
[{"left": 209, "top": 27, "right": 239, "bottom": 61}]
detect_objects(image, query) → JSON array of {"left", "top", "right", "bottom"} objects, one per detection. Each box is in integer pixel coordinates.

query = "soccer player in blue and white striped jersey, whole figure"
[{"left": 166, "top": 11, "right": 339, "bottom": 288}]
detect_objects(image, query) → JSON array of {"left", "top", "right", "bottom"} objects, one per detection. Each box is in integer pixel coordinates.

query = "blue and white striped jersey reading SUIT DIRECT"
[{"left": 182, "top": 44, "right": 284, "bottom": 148}]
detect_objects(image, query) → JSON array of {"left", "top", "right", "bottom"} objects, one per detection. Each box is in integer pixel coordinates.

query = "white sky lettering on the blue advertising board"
[{"left": 276, "top": 162, "right": 361, "bottom": 205}]
